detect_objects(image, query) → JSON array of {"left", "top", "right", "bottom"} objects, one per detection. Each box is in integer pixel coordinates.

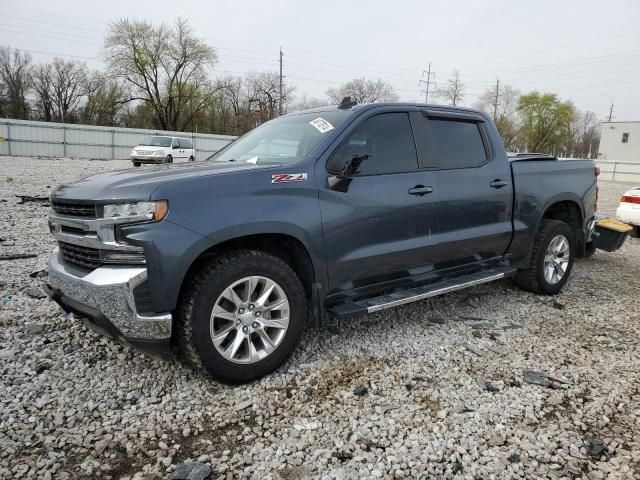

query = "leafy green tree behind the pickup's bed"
[{"left": 518, "top": 92, "right": 576, "bottom": 153}]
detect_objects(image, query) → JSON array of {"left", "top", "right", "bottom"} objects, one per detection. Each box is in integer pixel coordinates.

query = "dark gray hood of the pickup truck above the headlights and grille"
[{"left": 51, "top": 162, "right": 274, "bottom": 203}]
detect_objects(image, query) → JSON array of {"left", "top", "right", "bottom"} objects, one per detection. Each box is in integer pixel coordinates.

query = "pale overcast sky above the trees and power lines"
[{"left": 0, "top": 0, "right": 640, "bottom": 121}]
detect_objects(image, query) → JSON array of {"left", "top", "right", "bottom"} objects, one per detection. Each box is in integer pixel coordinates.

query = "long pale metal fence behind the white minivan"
[{"left": 0, "top": 119, "right": 236, "bottom": 160}]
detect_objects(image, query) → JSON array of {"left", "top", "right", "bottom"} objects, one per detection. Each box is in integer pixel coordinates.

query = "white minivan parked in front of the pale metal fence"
[{"left": 129, "top": 135, "right": 196, "bottom": 167}]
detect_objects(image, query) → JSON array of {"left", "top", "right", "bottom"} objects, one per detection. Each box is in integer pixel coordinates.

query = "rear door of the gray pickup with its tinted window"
[{"left": 411, "top": 111, "right": 513, "bottom": 268}]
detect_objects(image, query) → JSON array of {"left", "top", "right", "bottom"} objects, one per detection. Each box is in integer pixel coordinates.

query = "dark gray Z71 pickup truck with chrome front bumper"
[{"left": 48, "top": 99, "right": 598, "bottom": 383}]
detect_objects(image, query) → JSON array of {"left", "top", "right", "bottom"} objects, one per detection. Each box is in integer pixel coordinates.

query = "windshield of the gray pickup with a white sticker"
[{"left": 211, "top": 110, "right": 351, "bottom": 164}]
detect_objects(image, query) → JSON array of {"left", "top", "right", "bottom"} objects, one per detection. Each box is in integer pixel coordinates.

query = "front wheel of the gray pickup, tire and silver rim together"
[{"left": 178, "top": 250, "right": 307, "bottom": 384}]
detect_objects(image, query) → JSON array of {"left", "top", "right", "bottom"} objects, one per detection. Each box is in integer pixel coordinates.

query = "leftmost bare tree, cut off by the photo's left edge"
[{"left": 0, "top": 47, "right": 32, "bottom": 119}]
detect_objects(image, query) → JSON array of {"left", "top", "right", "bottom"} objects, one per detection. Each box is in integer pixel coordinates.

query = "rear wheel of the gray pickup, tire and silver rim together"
[{"left": 516, "top": 219, "right": 576, "bottom": 295}]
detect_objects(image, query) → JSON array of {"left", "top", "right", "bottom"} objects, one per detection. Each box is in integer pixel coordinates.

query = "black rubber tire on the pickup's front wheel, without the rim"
[{"left": 177, "top": 250, "right": 307, "bottom": 384}]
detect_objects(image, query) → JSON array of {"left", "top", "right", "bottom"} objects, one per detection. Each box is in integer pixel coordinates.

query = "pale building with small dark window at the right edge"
[{"left": 598, "top": 121, "right": 640, "bottom": 163}]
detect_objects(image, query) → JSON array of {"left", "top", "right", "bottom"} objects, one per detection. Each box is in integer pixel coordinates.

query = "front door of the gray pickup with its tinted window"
[{"left": 316, "top": 111, "right": 436, "bottom": 294}]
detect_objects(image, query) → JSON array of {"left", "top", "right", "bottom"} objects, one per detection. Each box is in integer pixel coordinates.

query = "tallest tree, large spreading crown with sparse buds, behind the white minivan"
[{"left": 105, "top": 19, "right": 216, "bottom": 130}]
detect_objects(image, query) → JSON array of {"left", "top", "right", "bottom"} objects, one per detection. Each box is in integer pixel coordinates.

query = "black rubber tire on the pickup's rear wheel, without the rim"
[{"left": 516, "top": 219, "right": 576, "bottom": 295}]
